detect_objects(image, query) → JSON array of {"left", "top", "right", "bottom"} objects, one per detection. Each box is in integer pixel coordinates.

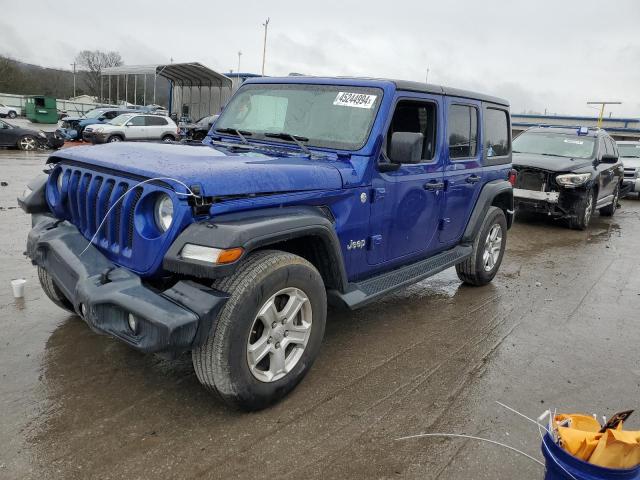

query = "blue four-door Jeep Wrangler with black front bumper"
[{"left": 19, "top": 77, "right": 513, "bottom": 410}]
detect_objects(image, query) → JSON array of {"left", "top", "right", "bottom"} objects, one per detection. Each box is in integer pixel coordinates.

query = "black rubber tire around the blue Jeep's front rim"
[{"left": 192, "top": 250, "right": 327, "bottom": 410}]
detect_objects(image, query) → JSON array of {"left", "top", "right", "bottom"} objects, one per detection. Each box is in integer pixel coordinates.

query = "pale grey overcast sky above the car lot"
[{"left": 0, "top": 0, "right": 640, "bottom": 117}]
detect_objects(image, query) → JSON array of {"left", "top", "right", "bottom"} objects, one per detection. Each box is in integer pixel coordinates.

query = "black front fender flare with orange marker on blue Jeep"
[{"left": 162, "top": 206, "right": 348, "bottom": 288}]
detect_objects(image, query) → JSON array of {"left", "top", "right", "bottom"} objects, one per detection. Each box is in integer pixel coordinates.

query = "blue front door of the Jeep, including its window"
[{"left": 367, "top": 92, "right": 444, "bottom": 265}]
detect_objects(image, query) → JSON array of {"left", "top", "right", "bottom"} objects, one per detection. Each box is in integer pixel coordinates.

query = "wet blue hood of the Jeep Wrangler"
[{"left": 48, "top": 142, "right": 342, "bottom": 196}]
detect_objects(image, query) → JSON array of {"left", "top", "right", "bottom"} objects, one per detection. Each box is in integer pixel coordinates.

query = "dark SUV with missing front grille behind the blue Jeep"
[{"left": 513, "top": 127, "right": 623, "bottom": 230}]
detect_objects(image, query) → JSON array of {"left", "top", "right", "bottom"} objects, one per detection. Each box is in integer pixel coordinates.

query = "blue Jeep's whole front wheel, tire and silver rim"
[{"left": 192, "top": 250, "right": 327, "bottom": 410}]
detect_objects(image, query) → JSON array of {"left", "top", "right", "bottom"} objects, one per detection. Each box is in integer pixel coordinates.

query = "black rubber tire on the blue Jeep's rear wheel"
[{"left": 456, "top": 207, "right": 507, "bottom": 286}]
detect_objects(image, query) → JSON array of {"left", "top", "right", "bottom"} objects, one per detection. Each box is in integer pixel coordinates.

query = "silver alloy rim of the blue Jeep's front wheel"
[{"left": 247, "top": 287, "right": 312, "bottom": 383}]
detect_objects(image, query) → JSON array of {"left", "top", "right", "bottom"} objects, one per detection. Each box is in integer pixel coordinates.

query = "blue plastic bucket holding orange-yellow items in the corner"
[{"left": 541, "top": 433, "right": 640, "bottom": 480}]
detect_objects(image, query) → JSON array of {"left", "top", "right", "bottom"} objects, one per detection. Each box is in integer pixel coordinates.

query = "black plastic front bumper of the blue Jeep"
[{"left": 27, "top": 214, "right": 228, "bottom": 355}]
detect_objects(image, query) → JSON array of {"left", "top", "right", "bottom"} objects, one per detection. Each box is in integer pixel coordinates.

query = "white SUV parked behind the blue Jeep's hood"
[{"left": 82, "top": 113, "right": 180, "bottom": 143}]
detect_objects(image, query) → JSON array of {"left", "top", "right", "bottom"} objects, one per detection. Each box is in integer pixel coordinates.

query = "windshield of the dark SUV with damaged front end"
[{"left": 513, "top": 132, "right": 595, "bottom": 158}]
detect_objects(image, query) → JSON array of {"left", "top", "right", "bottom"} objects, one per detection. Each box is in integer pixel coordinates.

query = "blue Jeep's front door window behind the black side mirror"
[{"left": 385, "top": 100, "right": 436, "bottom": 162}]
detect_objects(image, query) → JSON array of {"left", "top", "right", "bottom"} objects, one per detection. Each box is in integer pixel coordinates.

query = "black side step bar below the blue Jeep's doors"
[{"left": 328, "top": 245, "right": 472, "bottom": 310}]
